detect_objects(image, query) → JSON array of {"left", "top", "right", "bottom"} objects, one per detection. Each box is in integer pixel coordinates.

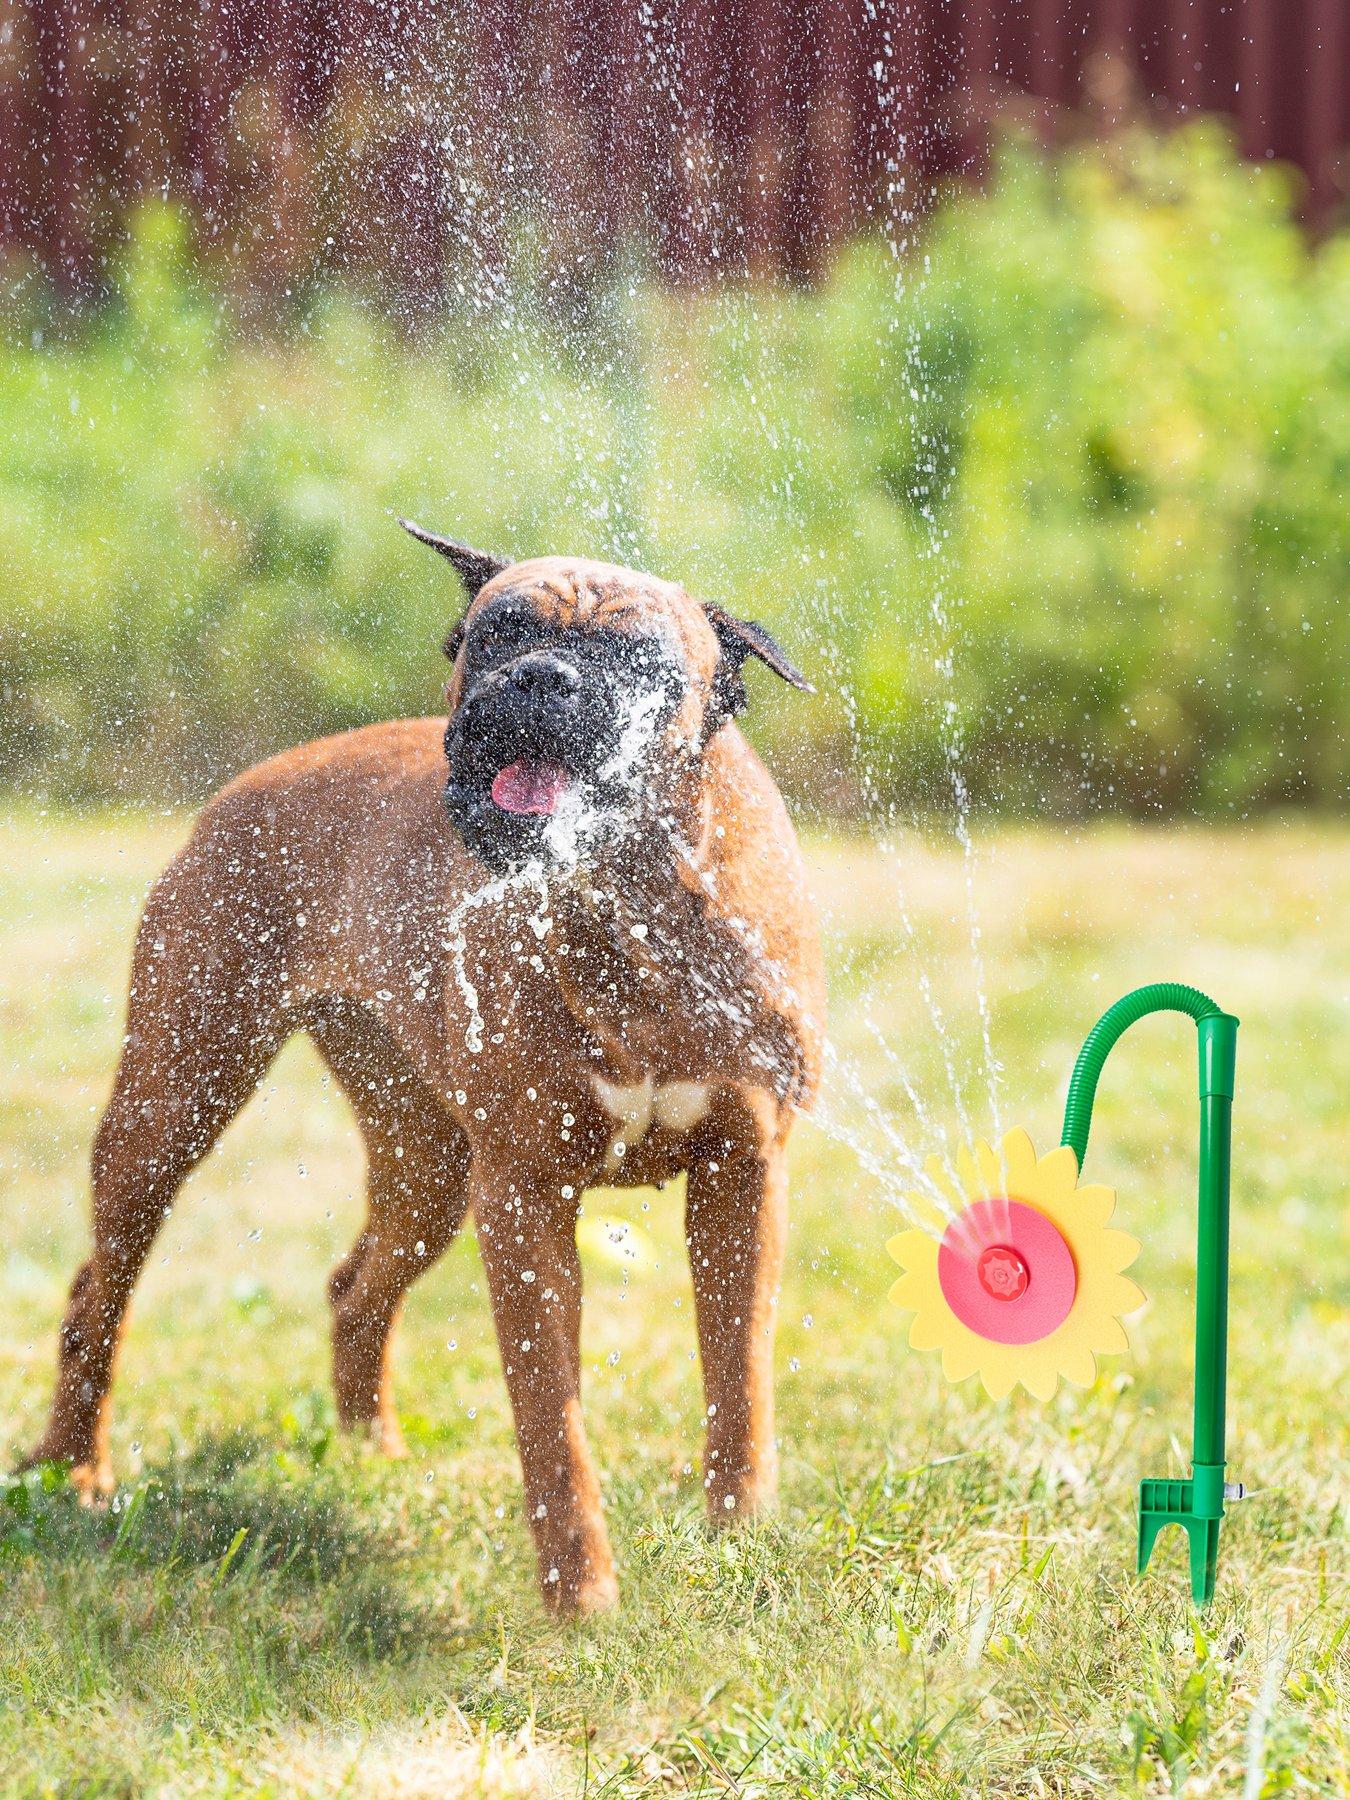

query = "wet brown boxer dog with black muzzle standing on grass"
[{"left": 32, "top": 526, "right": 823, "bottom": 1611}]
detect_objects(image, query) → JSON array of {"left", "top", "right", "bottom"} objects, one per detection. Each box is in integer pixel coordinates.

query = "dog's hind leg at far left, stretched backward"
[{"left": 27, "top": 846, "right": 286, "bottom": 1492}]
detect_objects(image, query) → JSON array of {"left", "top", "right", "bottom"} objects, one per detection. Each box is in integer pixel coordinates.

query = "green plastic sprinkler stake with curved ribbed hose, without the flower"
[{"left": 1062, "top": 981, "right": 1242, "bottom": 1606}]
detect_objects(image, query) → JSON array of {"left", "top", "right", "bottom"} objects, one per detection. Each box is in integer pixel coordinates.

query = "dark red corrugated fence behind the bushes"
[{"left": 0, "top": 0, "right": 1350, "bottom": 306}]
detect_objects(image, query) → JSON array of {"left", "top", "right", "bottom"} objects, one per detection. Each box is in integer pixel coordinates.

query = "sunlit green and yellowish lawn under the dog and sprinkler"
[{"left": 0, "top": 810, "right": 1350, "bottom": 1800}]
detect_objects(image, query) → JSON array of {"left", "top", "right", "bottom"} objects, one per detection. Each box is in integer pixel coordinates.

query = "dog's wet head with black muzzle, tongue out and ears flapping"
[{"left": 401, "top": 520, "right": 810, "bottom": 873}]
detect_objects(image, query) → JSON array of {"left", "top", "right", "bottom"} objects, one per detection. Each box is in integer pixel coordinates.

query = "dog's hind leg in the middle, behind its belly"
[{"left": 310, "top": 1001, "right": 468, "bottom": 1454}]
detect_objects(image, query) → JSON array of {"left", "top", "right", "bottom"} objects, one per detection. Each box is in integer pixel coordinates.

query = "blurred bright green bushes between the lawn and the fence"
[{"left": 0, "top": 124, "right": 1350, "bottom": 814}]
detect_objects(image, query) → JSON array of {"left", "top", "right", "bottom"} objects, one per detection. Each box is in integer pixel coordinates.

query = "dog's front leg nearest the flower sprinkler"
[{"left": 686, "top": 1141, "right": 787, "bottom": 1525}]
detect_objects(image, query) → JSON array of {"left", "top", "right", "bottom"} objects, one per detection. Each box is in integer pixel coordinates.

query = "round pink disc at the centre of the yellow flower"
[{"left": 938, "top": 1195, "right": 1078, "bottom": 1345}]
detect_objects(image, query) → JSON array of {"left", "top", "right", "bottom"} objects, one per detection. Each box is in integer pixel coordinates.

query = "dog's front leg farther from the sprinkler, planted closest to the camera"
[{"left": 472, "top": 1163, "right": 619, "bottom": 1613}]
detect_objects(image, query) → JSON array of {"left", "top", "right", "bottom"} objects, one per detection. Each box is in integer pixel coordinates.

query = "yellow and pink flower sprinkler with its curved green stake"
[{"left": 887, "top": 981, "right": 1242, "bottom": 1606}]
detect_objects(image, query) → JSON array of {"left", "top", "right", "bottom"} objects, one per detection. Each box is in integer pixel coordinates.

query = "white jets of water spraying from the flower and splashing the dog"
[{"left": 423, "top": 0, "right": 1003, "bottom": 1238}]
